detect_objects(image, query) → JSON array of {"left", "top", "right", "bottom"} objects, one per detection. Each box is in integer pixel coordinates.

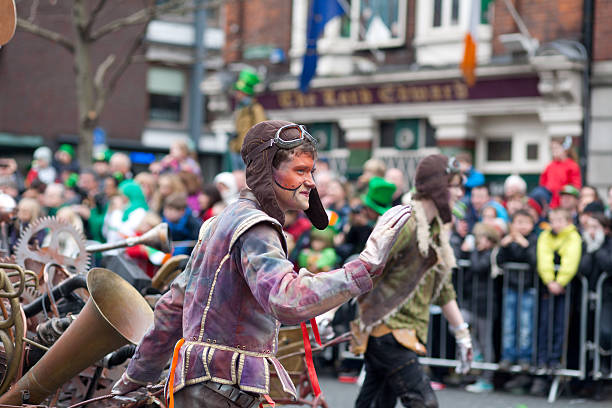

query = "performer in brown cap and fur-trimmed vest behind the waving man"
[{"left": 352, "top": 154, "right": 472, "bottom": 408}]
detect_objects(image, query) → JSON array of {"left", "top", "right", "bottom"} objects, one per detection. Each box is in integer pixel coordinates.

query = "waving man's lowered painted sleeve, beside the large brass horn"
[{"left": 126, "top": 259, "right": 191, "bottom": 385}]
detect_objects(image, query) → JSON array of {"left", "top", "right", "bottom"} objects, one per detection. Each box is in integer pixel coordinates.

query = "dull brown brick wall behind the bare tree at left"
[{"left": 0, "top": 0, "right": 147, "bottom": 143}]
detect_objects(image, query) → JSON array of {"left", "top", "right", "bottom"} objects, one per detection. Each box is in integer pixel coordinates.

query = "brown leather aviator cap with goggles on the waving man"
[{"left": 240, "top": 120, "right": 329, "bottom": 230}]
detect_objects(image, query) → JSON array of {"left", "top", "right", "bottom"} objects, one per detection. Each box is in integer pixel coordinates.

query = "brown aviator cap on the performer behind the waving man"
[{"left": 414, "top": 154, "right": 459, "bottom": 223}]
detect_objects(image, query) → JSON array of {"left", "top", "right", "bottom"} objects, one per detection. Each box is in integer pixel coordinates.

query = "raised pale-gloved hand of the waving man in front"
[{"left": 359, "top": 205, "right": 412, "bottom": 276}]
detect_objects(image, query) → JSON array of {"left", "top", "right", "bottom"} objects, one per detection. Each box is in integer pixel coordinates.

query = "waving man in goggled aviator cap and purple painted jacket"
[{"left": 113, "top": 121, "right": 411, "bottom": 408}]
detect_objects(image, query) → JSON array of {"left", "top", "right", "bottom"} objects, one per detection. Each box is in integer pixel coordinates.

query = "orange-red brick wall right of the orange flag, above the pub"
[{"left": 493, "top": 0, "right": 584, "bottom": 55}]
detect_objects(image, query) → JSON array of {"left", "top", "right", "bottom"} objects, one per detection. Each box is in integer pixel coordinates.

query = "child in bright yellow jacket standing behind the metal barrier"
[{"left": 537, "top": 208, "right": 582, "bottom": 370}]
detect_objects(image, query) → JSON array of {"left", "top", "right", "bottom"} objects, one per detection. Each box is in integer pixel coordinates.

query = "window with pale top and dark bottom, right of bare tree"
[{"left": 147, "top": 67, "right": 185, "bottom": 122}]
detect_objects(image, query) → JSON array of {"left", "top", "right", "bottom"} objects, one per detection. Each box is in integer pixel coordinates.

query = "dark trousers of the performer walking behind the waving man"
[{"left": 355, "top": 333, "right": 438, "bottom": 408}]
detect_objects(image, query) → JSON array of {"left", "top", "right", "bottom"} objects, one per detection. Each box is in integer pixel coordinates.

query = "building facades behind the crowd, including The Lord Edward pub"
[{"left": 0, "top": 0, "right": 612, "bottom": 189}]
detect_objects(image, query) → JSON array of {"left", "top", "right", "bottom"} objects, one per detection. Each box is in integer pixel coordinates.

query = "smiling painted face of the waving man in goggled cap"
[{"left": 272, "top": 152, "right": 316, "bottom": 212}]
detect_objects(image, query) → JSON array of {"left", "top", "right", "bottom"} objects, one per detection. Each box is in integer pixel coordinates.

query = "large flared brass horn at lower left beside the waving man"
[{"left": 0, "top": 268, "right": 153, "bottom": 405}]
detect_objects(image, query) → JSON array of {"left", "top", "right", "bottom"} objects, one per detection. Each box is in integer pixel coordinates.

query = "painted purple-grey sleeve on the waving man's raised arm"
[{"left": 239, "top": 224, "right": 372, "bottom": 324}]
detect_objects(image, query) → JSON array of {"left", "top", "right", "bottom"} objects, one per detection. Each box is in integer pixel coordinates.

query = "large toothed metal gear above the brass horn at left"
[{"left": 15, "top": 217, "right": 89, "bottom": 275}]
